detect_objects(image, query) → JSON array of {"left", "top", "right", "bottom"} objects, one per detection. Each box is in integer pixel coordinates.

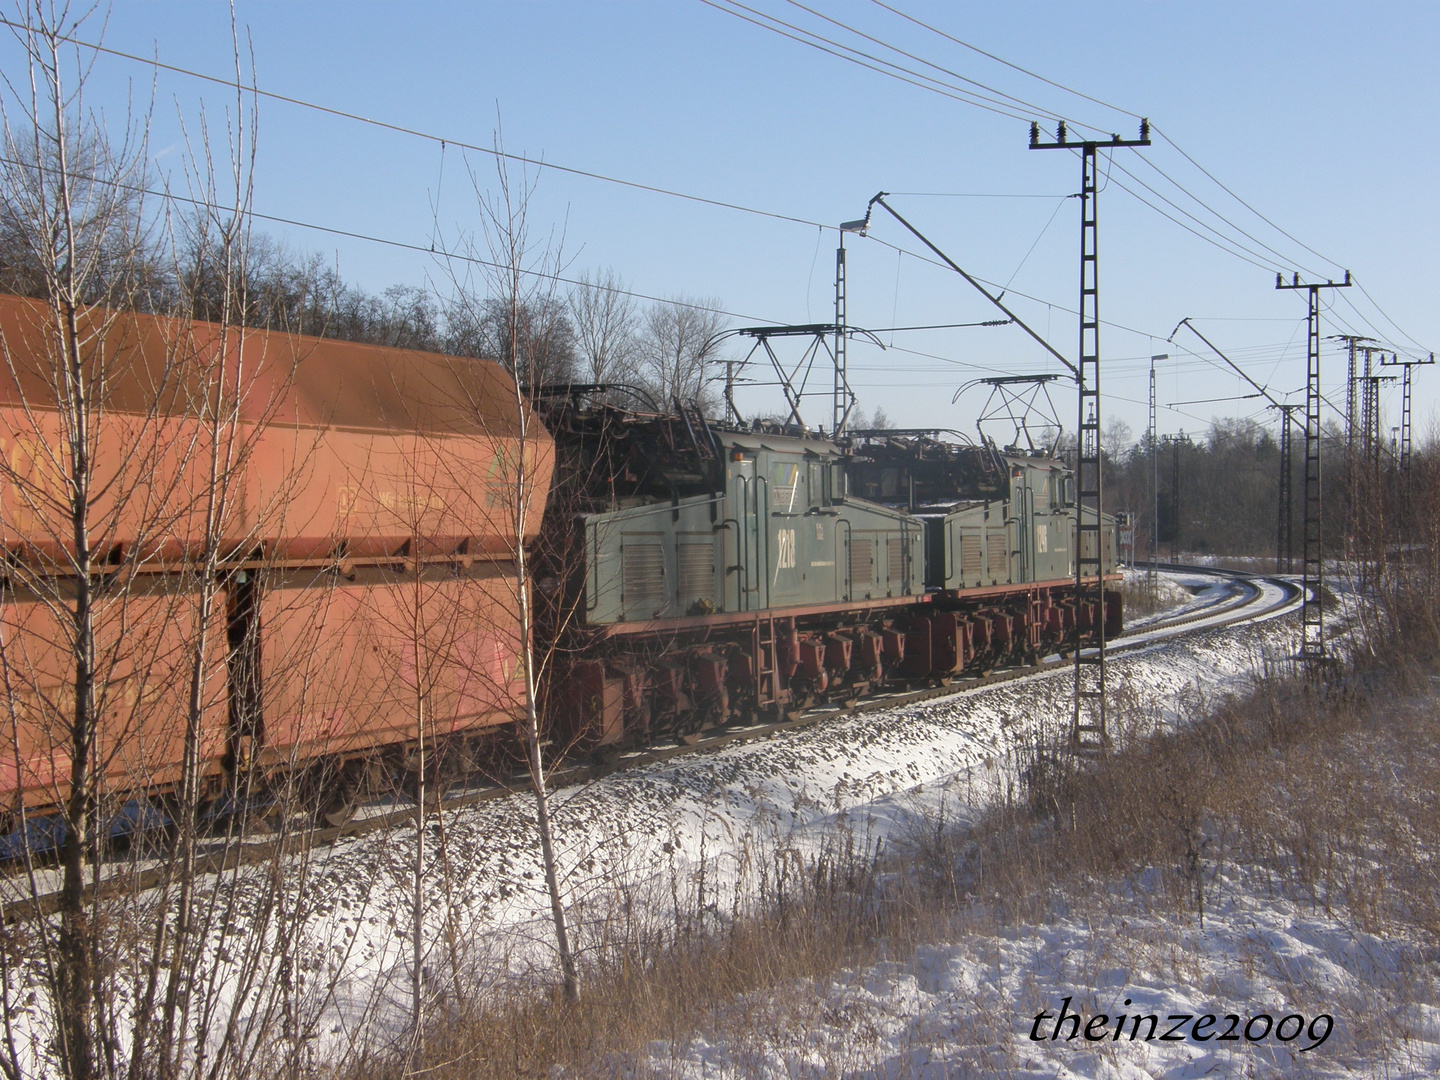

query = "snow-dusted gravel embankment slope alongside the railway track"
[{"left": 300, "top": 576, "right": 1295, "bottom": 1050}]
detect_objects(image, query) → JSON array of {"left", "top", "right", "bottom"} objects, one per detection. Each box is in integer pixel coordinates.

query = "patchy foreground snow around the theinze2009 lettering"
[{"left": 632, "top": 871, "right": 1440, "bottom": 1080}]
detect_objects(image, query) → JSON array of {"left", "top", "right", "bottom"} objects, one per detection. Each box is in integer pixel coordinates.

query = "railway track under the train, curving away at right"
[{"left": 0, "top": 563, "right": 1300, "bottom": 923}]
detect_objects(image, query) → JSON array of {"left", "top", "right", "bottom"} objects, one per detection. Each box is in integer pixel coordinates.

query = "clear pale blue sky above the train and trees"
[{"left": 14, "top": 0, "right": 1440, "bottom": 443}]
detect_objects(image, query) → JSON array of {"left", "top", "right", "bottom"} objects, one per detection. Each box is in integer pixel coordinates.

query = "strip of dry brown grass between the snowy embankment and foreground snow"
[{"left": 345, "top": 622, "right": 1440, "bottom": 1080}]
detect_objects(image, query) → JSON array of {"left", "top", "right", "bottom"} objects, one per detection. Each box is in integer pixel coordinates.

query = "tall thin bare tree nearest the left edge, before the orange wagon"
[{"left": 0, "top": 3, "right": 173, "bottom": 1079}]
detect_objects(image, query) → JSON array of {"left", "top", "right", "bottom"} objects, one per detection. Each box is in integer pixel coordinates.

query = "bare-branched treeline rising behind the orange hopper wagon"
[{"left": 0, "top": 158, "right": 729, "bottom": 408}]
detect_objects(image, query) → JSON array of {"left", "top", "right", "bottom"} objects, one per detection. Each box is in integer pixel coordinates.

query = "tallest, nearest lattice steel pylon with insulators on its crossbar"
[{"left": 1030, "top": 120, "right": 1151, "bottom": 753}]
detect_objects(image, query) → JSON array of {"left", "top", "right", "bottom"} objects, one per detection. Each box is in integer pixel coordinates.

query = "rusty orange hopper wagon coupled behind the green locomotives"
[{"left": 0, "top": 297, "right": 554, "bottom": 811}]
